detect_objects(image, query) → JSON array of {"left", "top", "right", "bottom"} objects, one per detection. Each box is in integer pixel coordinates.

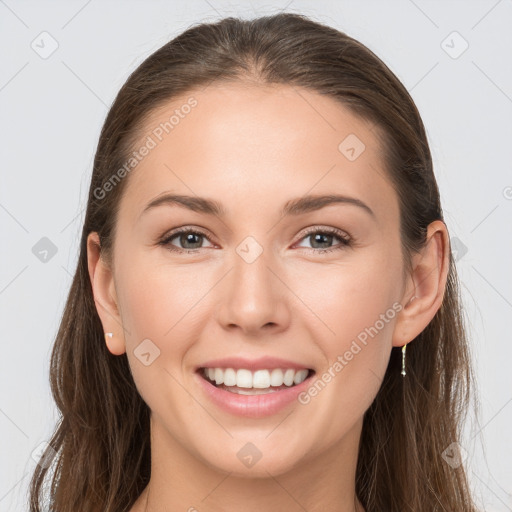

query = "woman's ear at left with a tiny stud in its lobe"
[{"left": 87, "top": 232, "right": 126, "bottom": 355}]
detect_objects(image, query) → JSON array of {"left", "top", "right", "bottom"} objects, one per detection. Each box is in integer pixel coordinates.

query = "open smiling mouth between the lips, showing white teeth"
[{"left": 197, "top": 367, "right": 315, "bottom": 395}]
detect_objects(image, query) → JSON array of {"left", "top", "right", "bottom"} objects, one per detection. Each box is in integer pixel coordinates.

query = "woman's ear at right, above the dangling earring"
[{"left": 393, "top": 220, "right": 450, "bottom": 347}]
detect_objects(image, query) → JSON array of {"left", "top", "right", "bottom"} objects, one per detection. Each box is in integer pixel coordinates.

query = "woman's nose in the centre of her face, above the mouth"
[{"left": 213, "top": 247, "right": 291, "bottom": 336}]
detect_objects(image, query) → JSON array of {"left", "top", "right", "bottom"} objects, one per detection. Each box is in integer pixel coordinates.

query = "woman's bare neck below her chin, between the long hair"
[{"left": 136, "top": 417, "right": 364, "bottom": 512}]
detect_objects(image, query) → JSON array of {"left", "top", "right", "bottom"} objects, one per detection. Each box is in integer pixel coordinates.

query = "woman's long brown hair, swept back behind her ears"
[{"left": 29, "top": 13, "right": 476, "bottom": 512}]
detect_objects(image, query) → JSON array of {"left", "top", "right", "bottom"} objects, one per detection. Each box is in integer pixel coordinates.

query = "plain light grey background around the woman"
[{"left": 0, "top": 0, "right": 512, "bottom": 512}]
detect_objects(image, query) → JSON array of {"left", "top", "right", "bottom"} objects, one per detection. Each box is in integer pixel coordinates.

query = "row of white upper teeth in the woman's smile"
[{"left": 203, "top": 368, "right": 309, "bottom": 389}]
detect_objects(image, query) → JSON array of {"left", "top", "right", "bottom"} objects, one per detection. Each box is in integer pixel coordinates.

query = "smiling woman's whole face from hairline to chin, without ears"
[{"left": 90, "top": 84, "right": 404, "bottom": 476}]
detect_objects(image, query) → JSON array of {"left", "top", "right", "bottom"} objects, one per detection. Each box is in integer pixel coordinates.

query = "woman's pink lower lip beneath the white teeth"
[{"left": 196, "top": 372, "right": 314, "bottom": 418}]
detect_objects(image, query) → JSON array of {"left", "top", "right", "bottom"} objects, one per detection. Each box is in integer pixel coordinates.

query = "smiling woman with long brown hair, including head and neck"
[{"left": 30, "top": 13, "right": 476, "bottom": 512}]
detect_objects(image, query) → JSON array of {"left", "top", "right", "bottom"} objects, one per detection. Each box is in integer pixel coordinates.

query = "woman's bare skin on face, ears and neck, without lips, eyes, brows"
[{"left": 88, "top": 83, "right": 449, "bottom": 512}]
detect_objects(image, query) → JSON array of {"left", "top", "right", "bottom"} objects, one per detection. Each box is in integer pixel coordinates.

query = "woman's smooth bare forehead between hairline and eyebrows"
[{"left": 122, "top": 82, "right": 398, "bottom": 226}]
